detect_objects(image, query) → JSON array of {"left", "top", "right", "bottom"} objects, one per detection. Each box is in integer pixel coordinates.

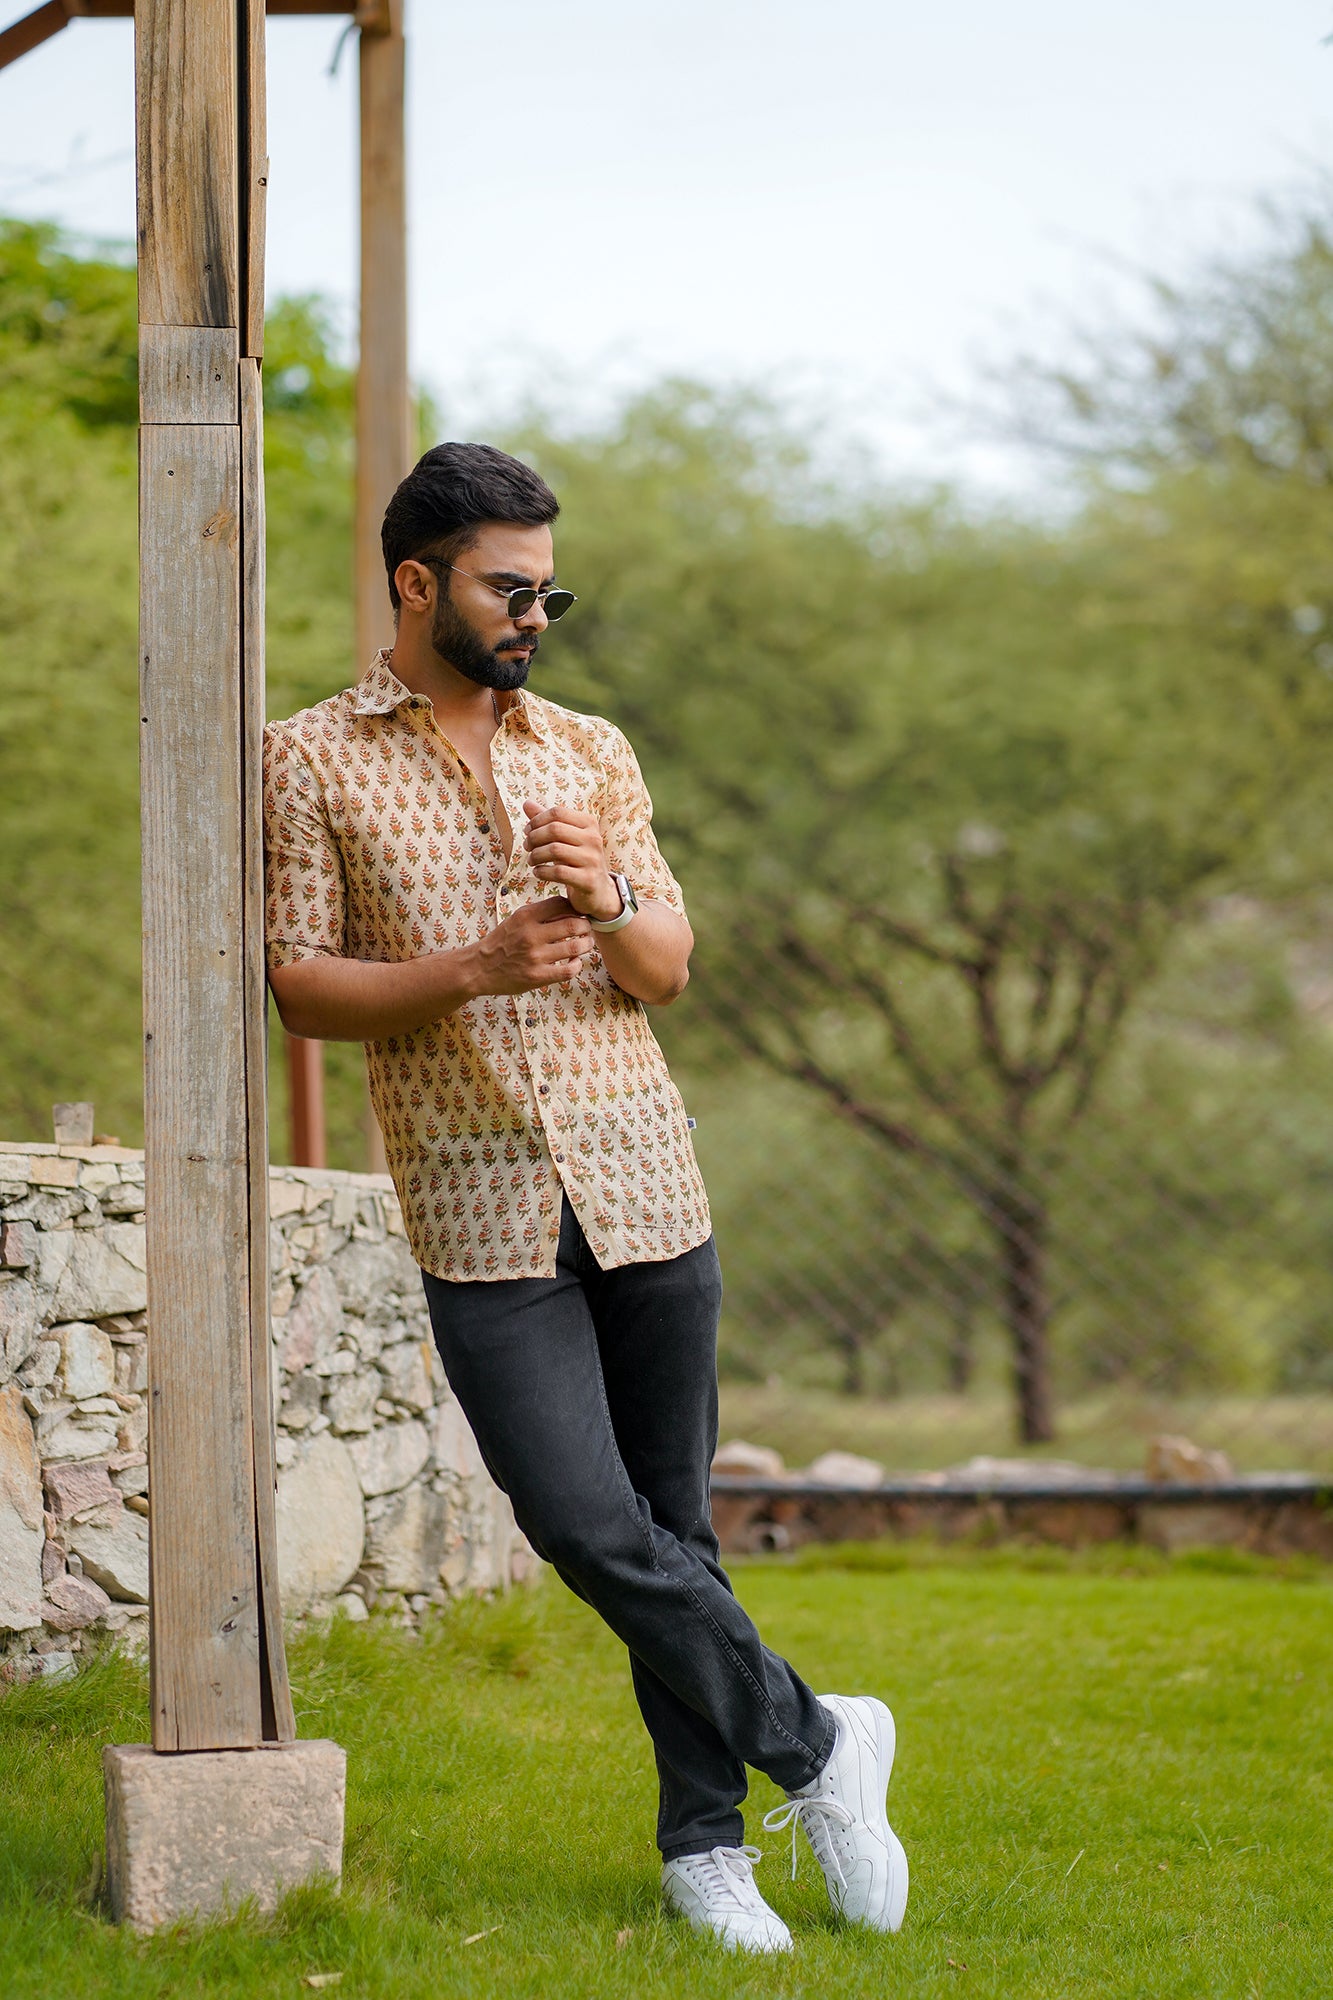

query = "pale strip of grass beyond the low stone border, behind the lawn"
[{"left": 723, "top": 1380, "right": 1333, "bottom": 1474}]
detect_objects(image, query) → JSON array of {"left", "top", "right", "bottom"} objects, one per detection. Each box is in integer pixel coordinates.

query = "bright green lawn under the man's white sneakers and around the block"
[{"left": 0, "top": 1546, "right": 1333, "bottom": 2000}]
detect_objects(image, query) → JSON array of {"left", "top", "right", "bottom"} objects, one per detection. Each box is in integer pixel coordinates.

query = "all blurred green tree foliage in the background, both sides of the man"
[{"left": 0, "top": 216, "right": 1333, "bottom": 1448}]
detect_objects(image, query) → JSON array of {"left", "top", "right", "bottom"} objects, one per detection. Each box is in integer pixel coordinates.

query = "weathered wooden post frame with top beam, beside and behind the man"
[{"left": 0, "top": 0, "right": 410, "bottom": 1752}]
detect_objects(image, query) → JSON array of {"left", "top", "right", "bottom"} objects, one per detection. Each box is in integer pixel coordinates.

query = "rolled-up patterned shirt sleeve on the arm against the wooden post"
[{"left": 264, "top": 724, "right": 346, "bottom": 968}]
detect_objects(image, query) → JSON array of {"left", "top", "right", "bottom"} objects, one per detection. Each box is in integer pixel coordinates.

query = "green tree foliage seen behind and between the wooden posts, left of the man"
[{"left": 0, "top": 220, "right": 362, "bottom": 1166}]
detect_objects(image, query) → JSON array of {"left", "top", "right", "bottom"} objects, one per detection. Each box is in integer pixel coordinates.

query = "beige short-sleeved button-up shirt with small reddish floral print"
[{"left": 264, "top": 652, "right": 711, "bottom": 1278}]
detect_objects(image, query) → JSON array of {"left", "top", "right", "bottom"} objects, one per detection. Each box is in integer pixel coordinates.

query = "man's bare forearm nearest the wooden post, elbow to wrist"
[{"left": 268, "top": 944, "right": 480, "bottom": 1042}]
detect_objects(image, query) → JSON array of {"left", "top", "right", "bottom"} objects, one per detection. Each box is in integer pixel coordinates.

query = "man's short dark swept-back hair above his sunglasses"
[{"left": 380, "top": 444, "right": 560, "bottom": 610}]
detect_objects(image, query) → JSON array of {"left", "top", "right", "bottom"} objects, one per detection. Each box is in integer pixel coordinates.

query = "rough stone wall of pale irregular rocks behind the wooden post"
[{"left": 0, "top": 1142, "right": 534, "bottom": 1680}]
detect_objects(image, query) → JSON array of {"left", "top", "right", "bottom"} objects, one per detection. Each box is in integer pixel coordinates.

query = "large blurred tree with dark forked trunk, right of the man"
[{"left": 528, "top": 386, "right": 1333, "bottom": 1442}]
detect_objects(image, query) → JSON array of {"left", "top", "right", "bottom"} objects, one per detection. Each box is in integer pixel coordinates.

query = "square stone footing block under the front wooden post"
[{"left": 102, "top": 1742, "right": 346, "bottom": 1930}]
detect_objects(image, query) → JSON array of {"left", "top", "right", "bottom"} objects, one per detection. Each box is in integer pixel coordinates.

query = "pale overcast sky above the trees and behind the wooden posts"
[{"left": 0, "top": 0, "right": 1333, "bottom": 478}]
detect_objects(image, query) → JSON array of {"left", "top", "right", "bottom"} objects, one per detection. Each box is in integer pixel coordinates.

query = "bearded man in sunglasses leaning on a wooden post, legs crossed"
[{"left": 264, "top": 444, "right": 907, "bottom": 1950}]
